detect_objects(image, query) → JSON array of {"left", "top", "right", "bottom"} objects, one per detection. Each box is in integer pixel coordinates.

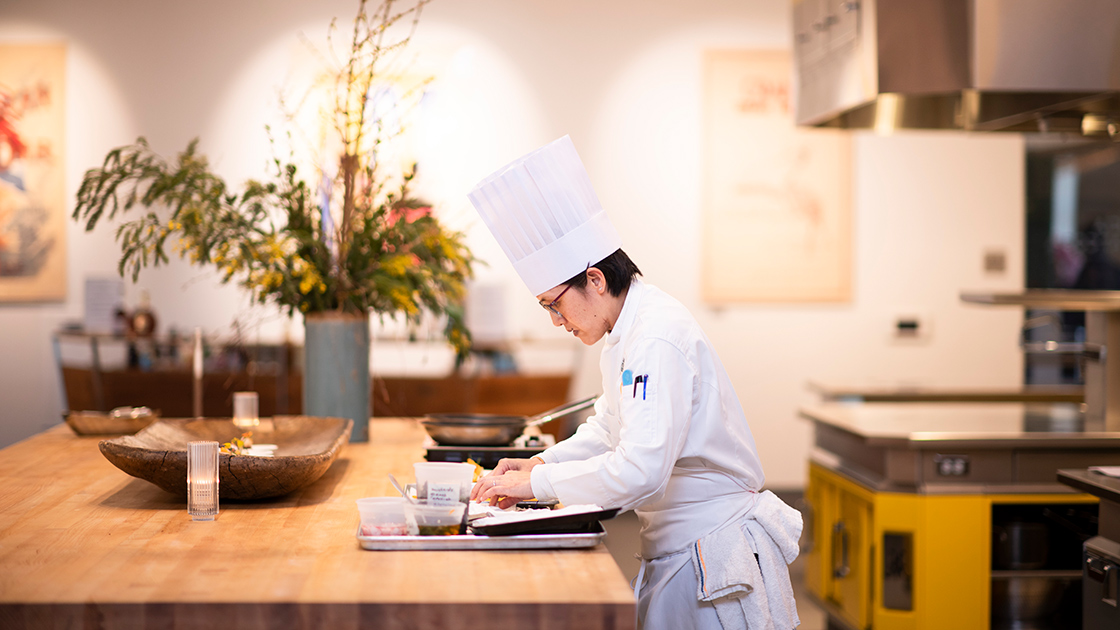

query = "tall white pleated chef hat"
[{"left": 467, "top": 136, "right": 623, "bottom": 295}]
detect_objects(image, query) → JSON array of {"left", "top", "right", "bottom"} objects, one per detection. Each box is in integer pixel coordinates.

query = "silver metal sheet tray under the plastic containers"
[{"left": 357, "top": 524, "right": 607, "bottom": 552}]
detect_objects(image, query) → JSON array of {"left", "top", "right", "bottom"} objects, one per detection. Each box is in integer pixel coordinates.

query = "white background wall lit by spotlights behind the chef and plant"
[{"left": 0, "top": 0, "right": 1025, "bottom": 487}]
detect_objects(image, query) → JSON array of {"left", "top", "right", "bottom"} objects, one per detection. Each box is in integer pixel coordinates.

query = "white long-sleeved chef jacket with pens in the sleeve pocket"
[{"left": 531, "top": 279, "right": 764, "bottom": 558}]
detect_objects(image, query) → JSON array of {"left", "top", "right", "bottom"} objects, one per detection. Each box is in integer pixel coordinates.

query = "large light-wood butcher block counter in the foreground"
[{"left": 0, "top": 418, "right": 636, "bottom": 630}]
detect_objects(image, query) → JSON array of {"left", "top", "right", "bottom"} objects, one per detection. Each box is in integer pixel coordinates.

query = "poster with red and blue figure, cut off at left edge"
[{"left": 0, "top": 44, "right": 66, "bottom": 302}]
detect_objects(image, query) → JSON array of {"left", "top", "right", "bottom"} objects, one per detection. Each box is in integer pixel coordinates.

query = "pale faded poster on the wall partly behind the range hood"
[{"left": 701, "top": 50, "right": 851, "bottom": 304}]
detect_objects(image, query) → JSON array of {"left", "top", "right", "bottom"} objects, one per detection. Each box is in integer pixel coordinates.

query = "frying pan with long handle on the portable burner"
[{"left": 420, "top": 396, "right": 598, "bottom": 446}]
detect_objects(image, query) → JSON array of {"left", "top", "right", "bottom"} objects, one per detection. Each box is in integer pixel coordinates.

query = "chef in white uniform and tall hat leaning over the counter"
[{"left": 469, "top": 136, "right": 801, "bottom": 630}]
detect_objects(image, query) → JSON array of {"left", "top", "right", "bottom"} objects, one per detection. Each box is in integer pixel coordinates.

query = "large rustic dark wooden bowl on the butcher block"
[{"left": 104, "top": 416, "right": 354, "bottom": 501}]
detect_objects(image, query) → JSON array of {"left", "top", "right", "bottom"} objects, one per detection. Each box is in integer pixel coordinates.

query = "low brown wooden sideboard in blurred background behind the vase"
[{"left": 53, "top": 328, "right": 575, "bottom": 437}]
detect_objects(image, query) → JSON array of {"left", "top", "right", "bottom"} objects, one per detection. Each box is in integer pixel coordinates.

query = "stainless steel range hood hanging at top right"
[{"left": 794, "top": 0, "right": 1120, "bottom": 140}]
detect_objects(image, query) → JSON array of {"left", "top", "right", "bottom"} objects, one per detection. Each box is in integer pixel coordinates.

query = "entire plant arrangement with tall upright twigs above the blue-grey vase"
[{"left": 73, "top": 0, "right": 475, "bottom": 359}]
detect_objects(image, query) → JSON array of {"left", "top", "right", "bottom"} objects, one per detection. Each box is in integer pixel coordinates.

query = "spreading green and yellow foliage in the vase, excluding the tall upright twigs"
[{"left": 73, "top": 138, "right": 475, "bottom": 355}]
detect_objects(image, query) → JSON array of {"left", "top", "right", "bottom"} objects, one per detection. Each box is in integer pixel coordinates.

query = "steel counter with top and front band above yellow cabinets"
[{"left": 800, "top": 402, "right": 1120, "bottom": 493}]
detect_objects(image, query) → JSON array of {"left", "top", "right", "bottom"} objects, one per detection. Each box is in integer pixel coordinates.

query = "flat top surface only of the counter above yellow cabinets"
[{"left": 799, "top": 402, "right": 1120, "bottom": 448}]
